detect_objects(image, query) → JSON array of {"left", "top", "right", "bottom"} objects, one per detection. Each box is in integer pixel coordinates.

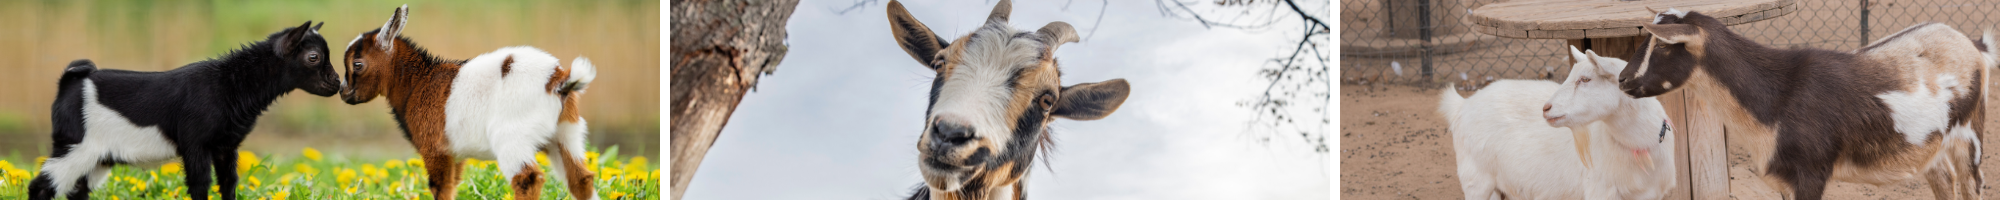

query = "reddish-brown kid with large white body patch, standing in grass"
[{"left": 340, "top": 6, "right": 596, "bottom": 200}]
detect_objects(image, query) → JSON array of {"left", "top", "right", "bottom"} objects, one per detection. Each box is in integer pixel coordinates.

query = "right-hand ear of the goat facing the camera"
[{"left": 1050, "top": 78, "right": 1132, "bottom": 120}]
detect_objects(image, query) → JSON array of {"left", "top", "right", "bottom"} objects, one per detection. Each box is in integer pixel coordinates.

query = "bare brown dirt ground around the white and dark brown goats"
[{"left": 1340, "top": 84, "right": 2000, "bottom": 200}]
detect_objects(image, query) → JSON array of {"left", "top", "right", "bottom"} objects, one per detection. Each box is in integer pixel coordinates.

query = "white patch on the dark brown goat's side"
[{"left": 1876, "top": 74, "right": 1966, "bottom": 146}]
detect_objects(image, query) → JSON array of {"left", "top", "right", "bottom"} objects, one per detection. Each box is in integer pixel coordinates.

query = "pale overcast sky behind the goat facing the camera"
[{"left": 684, "top": 0, "right": 1332, "bottom": 200}]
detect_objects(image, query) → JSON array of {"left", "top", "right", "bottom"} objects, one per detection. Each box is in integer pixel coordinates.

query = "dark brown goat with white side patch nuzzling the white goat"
[{"left": 1618, "top": 10, "right": 1996, "bottom": 200}]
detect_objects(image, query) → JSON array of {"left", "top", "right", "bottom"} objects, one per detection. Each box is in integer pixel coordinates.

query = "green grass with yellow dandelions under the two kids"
[{"left": 0, "top": 146, "right": 660, "bottom": 200}]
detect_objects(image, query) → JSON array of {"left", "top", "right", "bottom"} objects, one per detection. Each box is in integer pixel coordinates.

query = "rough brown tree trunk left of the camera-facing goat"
[{"left": 666, "top": 0, "right": 798, "bottom": 200}]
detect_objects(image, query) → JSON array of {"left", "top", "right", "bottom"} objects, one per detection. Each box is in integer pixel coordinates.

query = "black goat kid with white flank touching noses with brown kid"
[{"left": 28, "top": 20, "right": 342, "bottom": 200}]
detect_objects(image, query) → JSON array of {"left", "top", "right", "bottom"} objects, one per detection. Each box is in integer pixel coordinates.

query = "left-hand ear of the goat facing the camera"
[{"left": 888, "top": 0, "right": 950, "bottom": 70}]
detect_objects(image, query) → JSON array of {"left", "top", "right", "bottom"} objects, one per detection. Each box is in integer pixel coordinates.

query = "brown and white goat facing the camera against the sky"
[{"left": 888, "top": 0, "right": 1130, "bottom": 200}]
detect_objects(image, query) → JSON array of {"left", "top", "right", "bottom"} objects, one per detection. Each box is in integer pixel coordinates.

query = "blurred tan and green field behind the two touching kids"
[{"left": 0, "top": 0, "right": 662, "bottom": 160}]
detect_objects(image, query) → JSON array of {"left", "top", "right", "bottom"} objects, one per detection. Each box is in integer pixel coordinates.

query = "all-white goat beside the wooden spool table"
[{"left": 1438, "top": 48, "right": 1676, "bottom": 200}]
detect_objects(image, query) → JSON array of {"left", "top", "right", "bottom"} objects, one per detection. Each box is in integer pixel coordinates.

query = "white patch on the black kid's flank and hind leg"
[{"left": 42, "top": 80, "right": 180, "bottom": 196}]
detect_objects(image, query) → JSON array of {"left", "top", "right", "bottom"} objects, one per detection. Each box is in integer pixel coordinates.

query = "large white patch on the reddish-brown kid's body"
[{"left": 444, "top": 46, "right": 562, "bottom": 178}]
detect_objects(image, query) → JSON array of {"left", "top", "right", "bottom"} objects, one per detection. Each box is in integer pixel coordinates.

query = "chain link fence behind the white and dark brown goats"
[{"left": 1340, "top": 0, "right": 2000, "bottom": 86}]
